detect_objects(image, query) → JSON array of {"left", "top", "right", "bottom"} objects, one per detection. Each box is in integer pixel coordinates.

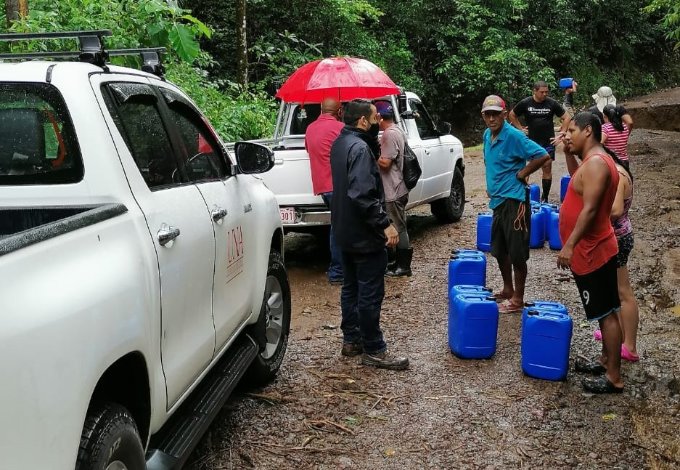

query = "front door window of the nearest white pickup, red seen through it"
[{"left": 161, "top": 88, "right": 228, "bottom": 181}]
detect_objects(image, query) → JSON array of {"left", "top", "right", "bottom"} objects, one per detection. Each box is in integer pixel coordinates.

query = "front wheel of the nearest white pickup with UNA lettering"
[{"left": 248, "top": 251, "right": 291, "bottom": 385}]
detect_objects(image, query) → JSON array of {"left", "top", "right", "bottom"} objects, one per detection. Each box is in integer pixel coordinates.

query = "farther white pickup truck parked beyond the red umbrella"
[{"left": 257, "top": 92, "right": 465, "bottom": 231}]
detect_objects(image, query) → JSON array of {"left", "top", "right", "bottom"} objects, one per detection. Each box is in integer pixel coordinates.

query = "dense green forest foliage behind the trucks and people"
[{"left": 1, "top": 0, "right": 680, "bottom": 140}]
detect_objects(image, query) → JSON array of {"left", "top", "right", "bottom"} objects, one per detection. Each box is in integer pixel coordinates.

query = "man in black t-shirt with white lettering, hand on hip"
[{"left": 508, "top": 80, "right": 571, "bottom": 202}]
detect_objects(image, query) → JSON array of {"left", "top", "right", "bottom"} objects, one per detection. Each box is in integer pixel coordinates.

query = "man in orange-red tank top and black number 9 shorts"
[{"left": 557, "top": 112, "right": 623, "bottom": 393}]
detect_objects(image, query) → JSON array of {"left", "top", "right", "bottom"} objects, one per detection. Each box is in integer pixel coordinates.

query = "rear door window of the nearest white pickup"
[{"left": 103, "top": 83, "right": 181, "bottom": 189}]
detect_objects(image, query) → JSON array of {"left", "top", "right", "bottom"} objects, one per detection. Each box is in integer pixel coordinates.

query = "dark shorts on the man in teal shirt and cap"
[{"left": 491, "top": 199, "right": 531, "bottom": 264}]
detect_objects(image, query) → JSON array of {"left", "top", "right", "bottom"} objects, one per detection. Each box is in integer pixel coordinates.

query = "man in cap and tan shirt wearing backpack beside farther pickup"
[{"left": 375, "top": 100, "right": 413, "bottom": 277}]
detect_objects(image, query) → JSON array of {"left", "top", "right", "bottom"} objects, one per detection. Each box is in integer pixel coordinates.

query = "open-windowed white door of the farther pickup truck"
[{"left": 409, "top": 98, "right": 453, "bottom": 199}]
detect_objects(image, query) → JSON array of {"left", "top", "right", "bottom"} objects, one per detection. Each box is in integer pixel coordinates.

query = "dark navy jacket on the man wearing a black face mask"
[{"left": 331, "top": 126, "right": 390, "bottom": 253}]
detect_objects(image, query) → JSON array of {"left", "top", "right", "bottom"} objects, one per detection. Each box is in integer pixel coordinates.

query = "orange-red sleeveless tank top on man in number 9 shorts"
[{"left": 560, "top": 153, "right": 619, "bottom": 276}]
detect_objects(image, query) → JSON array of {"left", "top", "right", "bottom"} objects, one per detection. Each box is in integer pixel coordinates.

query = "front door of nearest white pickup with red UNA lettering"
[{"left": 160, "top": 88, "right": 254, "bottom": 351}]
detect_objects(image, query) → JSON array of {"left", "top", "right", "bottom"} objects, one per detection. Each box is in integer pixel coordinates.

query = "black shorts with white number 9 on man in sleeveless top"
[{"left": 572, "top": 256, "right": 621, "bottom": 321}]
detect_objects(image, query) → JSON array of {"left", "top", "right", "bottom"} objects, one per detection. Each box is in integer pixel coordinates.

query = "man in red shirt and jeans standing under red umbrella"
[{"left": 305, "top": 98, "right": 345, "bottom": 284}]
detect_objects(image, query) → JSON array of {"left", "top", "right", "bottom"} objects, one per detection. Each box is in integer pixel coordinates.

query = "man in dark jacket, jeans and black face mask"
[{"left": 331, "top": 100, "right": 408, "bottom": 370}]
